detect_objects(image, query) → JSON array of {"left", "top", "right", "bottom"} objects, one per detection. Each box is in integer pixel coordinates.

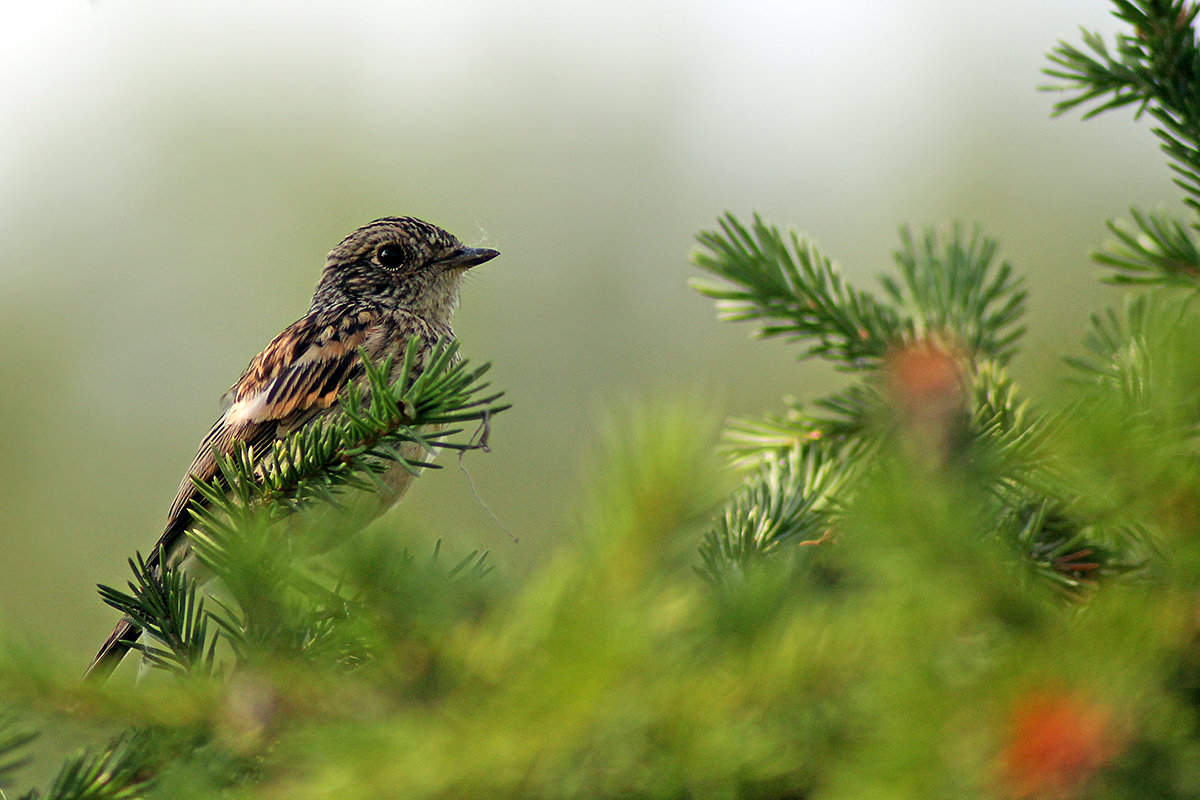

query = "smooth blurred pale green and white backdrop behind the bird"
[{"left": 0, "top": 0, "right": 1177, "bottom": 667}]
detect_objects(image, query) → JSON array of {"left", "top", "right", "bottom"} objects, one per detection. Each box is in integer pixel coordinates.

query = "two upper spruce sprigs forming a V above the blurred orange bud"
[{"left": 692, "top": 213, "right": 1025, "bottom": 371}]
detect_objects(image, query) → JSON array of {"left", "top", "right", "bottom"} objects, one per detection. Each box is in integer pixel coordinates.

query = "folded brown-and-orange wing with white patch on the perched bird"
[{"left": 149, "top": 304, "right": 379, "bottom": 566}]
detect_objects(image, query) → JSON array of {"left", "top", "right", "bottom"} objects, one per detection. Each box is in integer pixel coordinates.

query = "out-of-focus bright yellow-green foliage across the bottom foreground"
[{"left": 0, "top": 371, "right": 1200, "bottom": 798}]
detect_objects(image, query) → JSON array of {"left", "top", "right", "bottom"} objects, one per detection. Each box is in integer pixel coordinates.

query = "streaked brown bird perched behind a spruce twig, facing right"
[{"left": 84, "top": 217, "right": 499, "bottom": 681}]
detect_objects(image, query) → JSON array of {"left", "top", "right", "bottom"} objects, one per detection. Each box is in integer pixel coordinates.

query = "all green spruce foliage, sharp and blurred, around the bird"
[{"left": 0, "top": 0, "right": 1200, "bottom": 800}]
